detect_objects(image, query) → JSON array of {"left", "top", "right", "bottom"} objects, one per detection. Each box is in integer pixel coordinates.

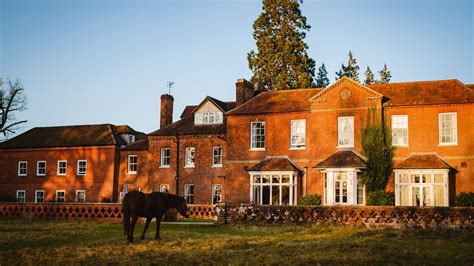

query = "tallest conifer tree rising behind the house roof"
[{"left": 247, "top": 0, "right": 315, "bottom": 90}]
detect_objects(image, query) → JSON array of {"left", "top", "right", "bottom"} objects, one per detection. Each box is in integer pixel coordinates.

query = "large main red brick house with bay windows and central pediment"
[{"left": 0, "top": 78, "right": 474, "bottom": 206}]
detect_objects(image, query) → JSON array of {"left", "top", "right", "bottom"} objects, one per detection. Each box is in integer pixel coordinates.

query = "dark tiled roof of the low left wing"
[{"left": 0, "top": 124, "right": 126, "bottom": 149}]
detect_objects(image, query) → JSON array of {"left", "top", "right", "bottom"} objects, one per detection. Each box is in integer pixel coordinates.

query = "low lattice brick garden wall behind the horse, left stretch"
[{"left": 0, "top": 203, "right": 214, "bottom": 222}]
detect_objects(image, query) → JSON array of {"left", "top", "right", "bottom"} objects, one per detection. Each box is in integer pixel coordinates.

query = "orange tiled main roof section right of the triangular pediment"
[{"left": 368, "top": 79, "right": 474, "bottom": 106}]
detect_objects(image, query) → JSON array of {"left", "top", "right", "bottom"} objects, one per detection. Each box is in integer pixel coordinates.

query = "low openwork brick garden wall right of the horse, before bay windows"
[{"left": 215, "top": 204, "right": 474, "bottom": 229}]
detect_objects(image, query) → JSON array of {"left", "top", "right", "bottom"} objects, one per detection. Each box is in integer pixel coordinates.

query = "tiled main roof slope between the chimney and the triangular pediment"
[{"left": 226, "top": 88, "right": 322, "bottom": 115}]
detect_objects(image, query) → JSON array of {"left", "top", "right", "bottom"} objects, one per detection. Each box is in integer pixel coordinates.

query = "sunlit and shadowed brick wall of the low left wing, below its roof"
[{"left": 0, "top": 146, "right": 116, "bottom": 202}]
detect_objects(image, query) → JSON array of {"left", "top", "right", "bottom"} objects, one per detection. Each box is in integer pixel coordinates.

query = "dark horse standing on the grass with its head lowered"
[{"left": 122, "top": 191, "right": 189, "bottom": 242}]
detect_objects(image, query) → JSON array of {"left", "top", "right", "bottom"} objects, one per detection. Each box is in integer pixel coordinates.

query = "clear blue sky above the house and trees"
[{"left": 0, "top": 0, "right": 474, "bottom": 133}]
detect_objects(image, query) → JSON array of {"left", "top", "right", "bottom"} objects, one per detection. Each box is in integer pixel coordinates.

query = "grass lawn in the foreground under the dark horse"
[{"left": 0, "top": 220, "right": 474, "bottom": 265}]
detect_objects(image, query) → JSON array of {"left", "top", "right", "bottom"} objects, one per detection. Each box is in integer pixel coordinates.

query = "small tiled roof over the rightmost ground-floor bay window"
[{"left": 393, "top": 153, "right": 453, "bottom": 169}]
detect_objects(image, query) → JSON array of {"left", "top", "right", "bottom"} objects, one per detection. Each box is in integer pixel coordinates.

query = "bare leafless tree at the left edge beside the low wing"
[{"left": 0, "top": 78, "right": 26, "bottom": 137}]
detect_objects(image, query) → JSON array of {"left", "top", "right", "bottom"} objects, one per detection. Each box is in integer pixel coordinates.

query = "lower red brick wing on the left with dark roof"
[{"left": 0, "top": 124, "right": 146, "bottom": 202}]
